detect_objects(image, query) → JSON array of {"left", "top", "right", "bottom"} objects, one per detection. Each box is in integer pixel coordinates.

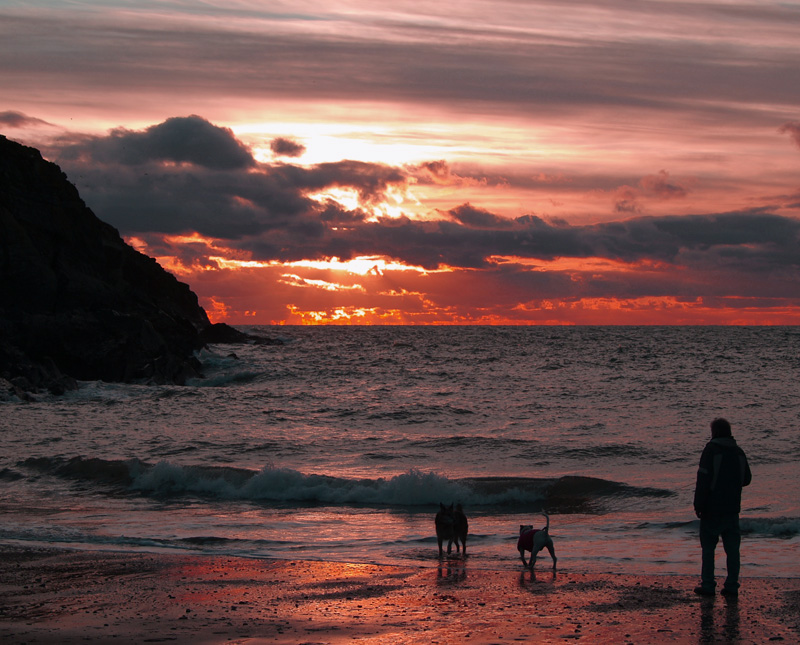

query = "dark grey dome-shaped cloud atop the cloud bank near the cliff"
[{"left": 62, "top": 116, "right": 255, "bottom": 170}]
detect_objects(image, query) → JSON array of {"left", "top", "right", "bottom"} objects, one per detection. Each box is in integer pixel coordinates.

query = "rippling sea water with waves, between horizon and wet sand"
[{"left": 0, "top": 326, "right": 800, "bottom": 577}]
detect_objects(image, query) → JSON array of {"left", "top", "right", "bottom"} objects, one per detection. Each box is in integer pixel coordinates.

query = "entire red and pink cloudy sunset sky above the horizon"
[{"left": 0, "top": 0, "right": 800, "bottom": 325}]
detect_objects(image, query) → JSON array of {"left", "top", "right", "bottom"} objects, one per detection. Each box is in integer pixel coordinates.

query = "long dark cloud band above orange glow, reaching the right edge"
[{"left": 243, "top": 201, "right": 800, "bottom": 275}]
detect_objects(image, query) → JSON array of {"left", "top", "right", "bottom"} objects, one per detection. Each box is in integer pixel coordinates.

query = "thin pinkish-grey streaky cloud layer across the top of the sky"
[{"left": 6, "top": 0, "right": 798, "bottom": 130}]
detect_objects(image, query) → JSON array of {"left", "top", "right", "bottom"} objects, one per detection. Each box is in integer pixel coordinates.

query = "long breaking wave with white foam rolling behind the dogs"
[{"left": 18, "top": 457, "right": 675, "bottom": 512}]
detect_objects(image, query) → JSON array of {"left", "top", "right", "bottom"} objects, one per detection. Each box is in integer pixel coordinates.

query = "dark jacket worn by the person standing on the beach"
[{"left": 694, "top": 437, "right": 752, "bottom": 516}]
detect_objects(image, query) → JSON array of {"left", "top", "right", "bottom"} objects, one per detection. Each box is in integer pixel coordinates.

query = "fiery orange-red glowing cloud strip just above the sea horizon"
[{"left": 136, "top": 233, "right": 800, "bottom": 324}]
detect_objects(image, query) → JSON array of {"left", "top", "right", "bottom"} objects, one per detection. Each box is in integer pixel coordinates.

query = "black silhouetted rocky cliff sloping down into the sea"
[{"left": 0, "top": 136, "right": 219, "bottom": 391}]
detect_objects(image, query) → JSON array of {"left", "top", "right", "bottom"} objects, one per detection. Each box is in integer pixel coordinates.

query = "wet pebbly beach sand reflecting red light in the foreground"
[{"left": 0, "top": 546, "right": 800, "bottom": 645}]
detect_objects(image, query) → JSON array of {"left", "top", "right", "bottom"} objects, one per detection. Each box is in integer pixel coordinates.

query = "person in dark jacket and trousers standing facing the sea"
[{"left": 694, "top": 419, "right": 752, "bottom": 596}]
